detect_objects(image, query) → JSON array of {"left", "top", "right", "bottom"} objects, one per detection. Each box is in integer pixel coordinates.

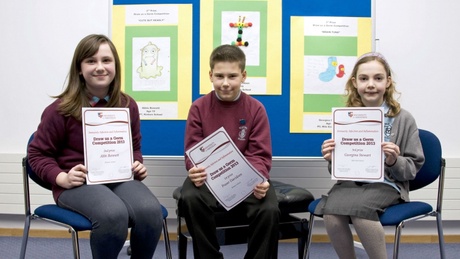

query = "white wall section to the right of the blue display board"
[{"left": 375, "top": 0, "right": 460, "bottom": 157}]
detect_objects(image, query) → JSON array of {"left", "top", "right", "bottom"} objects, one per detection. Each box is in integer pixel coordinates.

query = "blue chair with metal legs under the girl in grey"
[{"left": 304, "top": 129, "right": 446, "bottom": 258}]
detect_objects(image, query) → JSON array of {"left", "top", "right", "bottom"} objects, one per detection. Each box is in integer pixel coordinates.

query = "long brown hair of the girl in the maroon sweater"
[{"left": 53, "top": 34, "right": 129, "bottom": 120}]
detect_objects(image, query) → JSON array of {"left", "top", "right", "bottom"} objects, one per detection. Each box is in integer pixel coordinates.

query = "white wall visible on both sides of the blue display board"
[{"left": 0, "top": 0, "right": 460, "bottom": 158}]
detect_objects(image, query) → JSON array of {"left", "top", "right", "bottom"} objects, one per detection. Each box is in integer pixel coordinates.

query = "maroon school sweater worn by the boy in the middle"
[{"left": 185, "top": 91, "right": 272, "bottom": 179}]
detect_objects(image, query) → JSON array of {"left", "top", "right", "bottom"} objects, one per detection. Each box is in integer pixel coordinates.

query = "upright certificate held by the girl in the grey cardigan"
[{"left": 331, "top": 107, "right": 384, "bottom": 182}]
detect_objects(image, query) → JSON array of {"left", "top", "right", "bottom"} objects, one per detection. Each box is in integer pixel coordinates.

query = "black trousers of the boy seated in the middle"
[{"left": 179, "top": 177, "right": 280, "bottom": 259}]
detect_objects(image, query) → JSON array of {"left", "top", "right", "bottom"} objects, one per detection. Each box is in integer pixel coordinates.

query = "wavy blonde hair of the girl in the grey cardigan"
[{"left": 345, "top": 52, "right": 401, "bottom": 117}]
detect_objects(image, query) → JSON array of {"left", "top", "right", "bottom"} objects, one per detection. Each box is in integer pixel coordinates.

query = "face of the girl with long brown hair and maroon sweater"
[{"left": 80, "top": 43, "right": 116, "bottom": 98}]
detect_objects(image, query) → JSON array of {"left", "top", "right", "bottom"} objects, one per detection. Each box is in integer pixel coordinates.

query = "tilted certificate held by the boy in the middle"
[{"left": 185, "top": 127, "right": 266, "bottom": 210}]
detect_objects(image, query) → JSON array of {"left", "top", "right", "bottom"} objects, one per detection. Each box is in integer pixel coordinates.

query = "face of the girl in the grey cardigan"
[{"left": 352, "top": 60, "right": 391, "bottom": 107}]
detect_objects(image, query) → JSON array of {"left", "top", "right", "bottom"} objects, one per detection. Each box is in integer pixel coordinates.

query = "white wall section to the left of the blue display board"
[{"left": 0, "top": 0, "right": 111, "bottom": 155}]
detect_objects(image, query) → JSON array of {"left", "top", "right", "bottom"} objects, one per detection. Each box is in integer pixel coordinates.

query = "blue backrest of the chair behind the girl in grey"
[{"left": 409, "top": 129, "right": 444, "bottom": 191}]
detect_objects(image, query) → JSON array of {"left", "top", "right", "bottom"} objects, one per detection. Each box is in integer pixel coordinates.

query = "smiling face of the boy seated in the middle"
[{"left": 209, "top": 62, "right": 246, "bottom": 102}]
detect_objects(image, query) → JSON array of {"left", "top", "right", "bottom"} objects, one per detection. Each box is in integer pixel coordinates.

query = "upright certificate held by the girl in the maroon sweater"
[{"left": 82, "top": 108, "right": 133, "bottom": 184}]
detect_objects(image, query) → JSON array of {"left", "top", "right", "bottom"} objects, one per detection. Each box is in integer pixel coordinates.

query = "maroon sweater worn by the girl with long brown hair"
[{"left": 28, "top": 98, "right": 143, "bottom": 202}]
